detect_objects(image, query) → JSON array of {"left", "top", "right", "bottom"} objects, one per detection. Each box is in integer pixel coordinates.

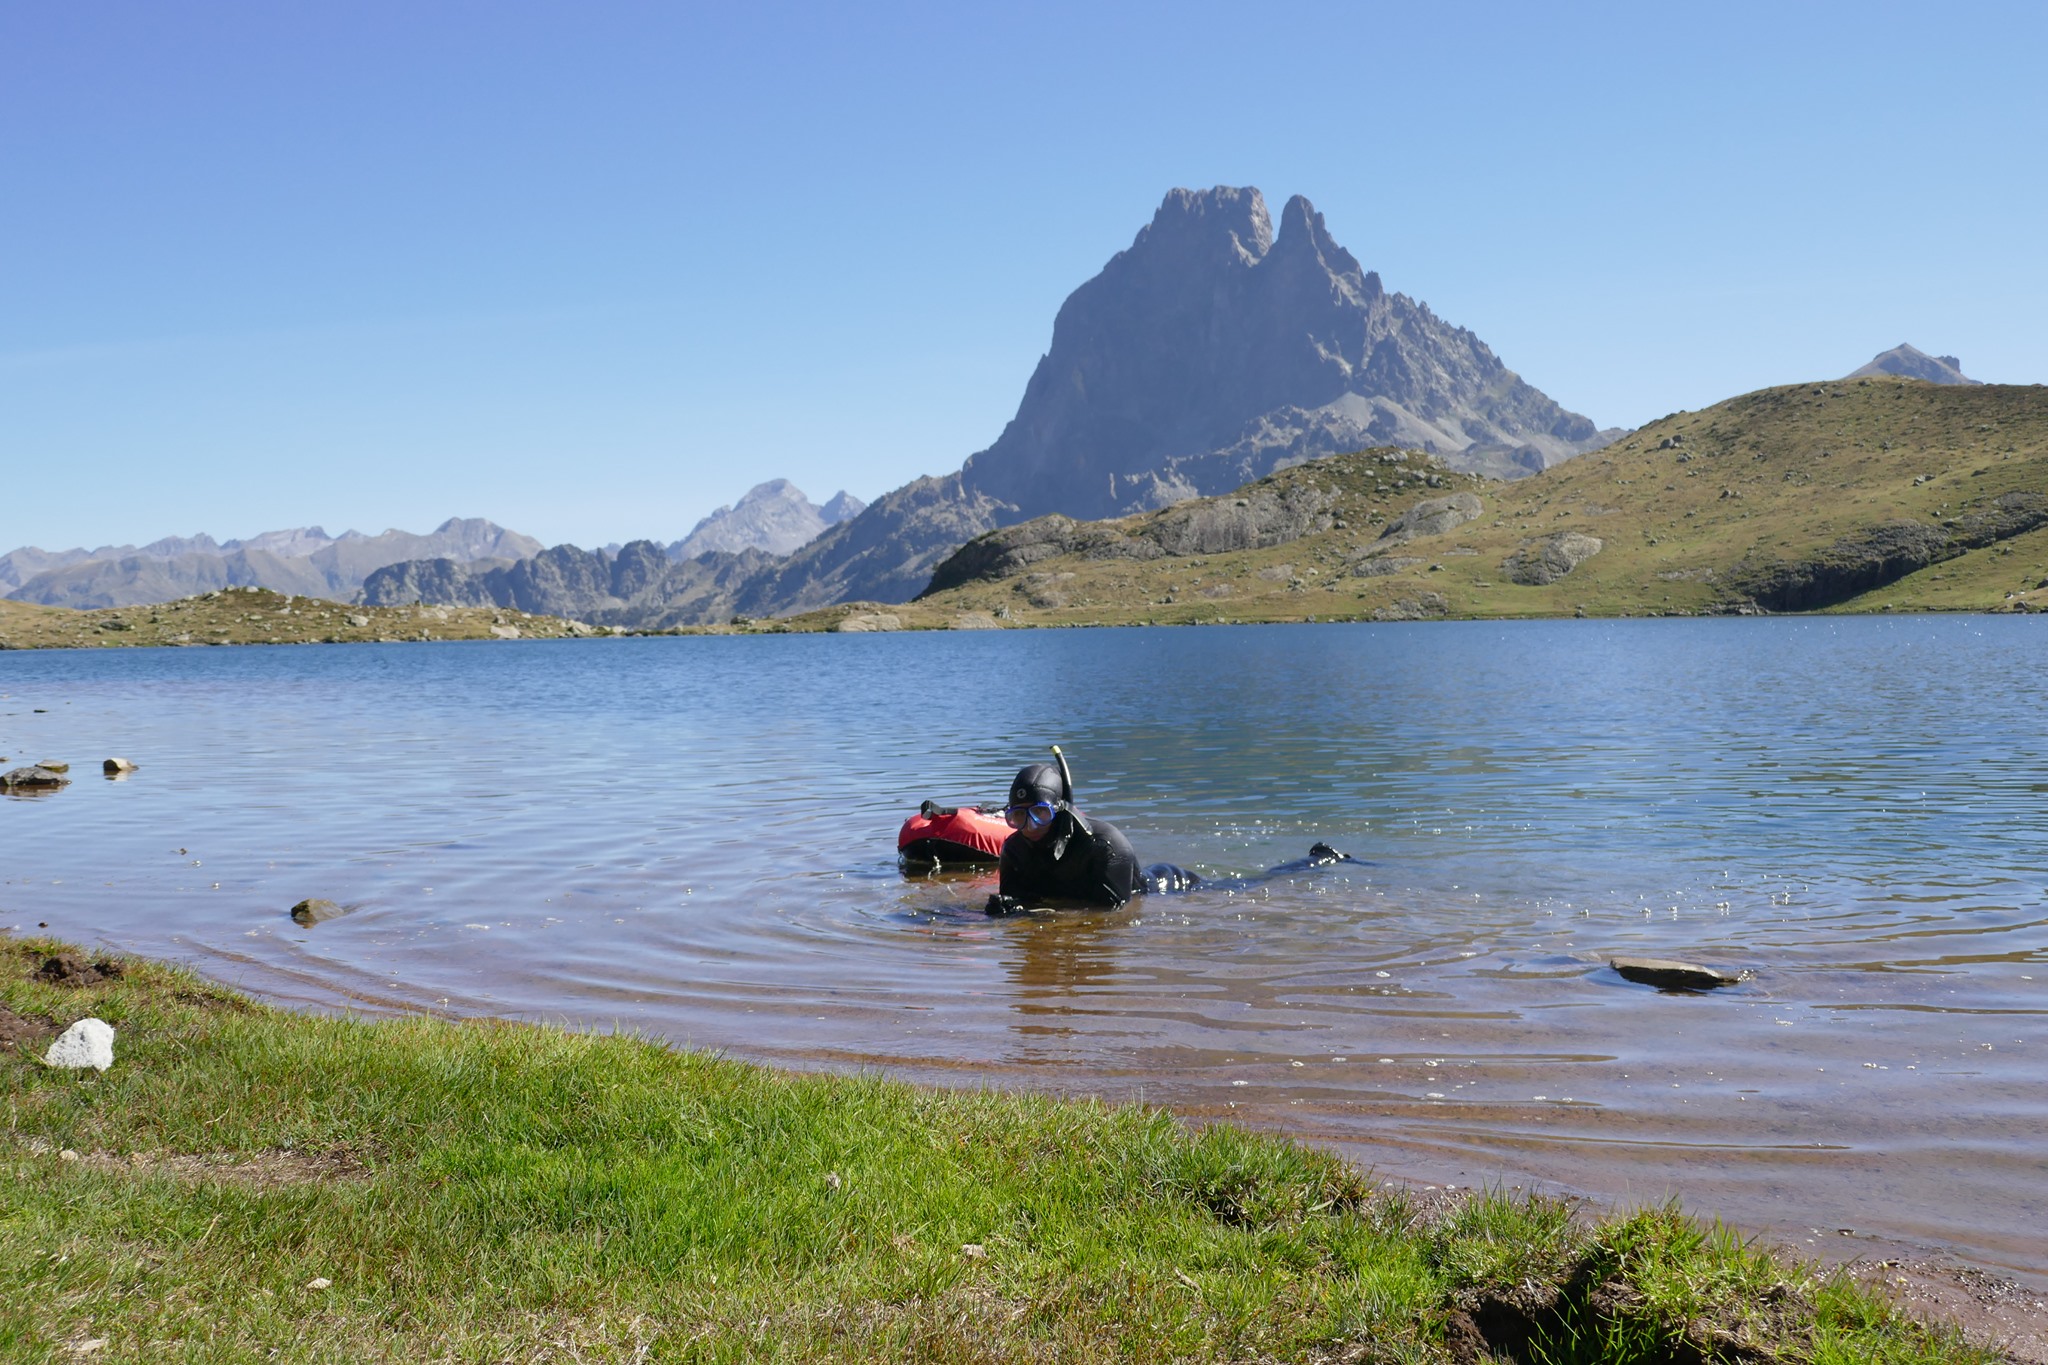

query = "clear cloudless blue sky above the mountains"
[{"left": 0, "top": 0, "right": 2048, "bottom": 551}]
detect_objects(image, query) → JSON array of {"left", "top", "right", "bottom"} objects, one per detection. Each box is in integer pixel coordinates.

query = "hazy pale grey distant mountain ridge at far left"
[{"left": 4, "top": 518, "right": 543, "bottom": 608}]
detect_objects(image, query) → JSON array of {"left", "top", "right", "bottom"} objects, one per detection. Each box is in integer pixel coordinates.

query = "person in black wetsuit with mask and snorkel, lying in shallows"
[{"left": 987, "top": 745, "right": 1198, "bottom": 915}]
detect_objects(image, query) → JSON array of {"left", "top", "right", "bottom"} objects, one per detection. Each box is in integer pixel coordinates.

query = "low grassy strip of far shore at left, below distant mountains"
[{"left": 0, "top": 587, "right": 596, "bottom": 649}]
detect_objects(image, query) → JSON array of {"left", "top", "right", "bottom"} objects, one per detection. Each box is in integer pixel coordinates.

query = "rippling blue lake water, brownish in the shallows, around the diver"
[{"left": 0, "top": 616, "right": 2048, "bottom": 1277}]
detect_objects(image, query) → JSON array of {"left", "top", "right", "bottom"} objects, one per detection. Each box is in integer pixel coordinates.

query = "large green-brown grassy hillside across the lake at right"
[{"left": 761, "top": 377, "right": 2048, "bottom": 628}]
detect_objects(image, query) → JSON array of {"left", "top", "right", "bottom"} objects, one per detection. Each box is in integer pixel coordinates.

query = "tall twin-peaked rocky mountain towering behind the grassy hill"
[{"left": 963, "top": 188, "right": 1612, "bottom": 518}]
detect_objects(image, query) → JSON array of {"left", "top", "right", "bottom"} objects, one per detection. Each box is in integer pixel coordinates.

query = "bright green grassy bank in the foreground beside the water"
[{"left": 0, "top": 939, "right": 1991, "bottom": 1363}]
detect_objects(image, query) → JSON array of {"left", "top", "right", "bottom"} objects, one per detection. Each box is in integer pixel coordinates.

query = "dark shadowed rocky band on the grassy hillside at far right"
[{"left": 1726, "top": 493, "right": 2048, "bottom": 612}]
